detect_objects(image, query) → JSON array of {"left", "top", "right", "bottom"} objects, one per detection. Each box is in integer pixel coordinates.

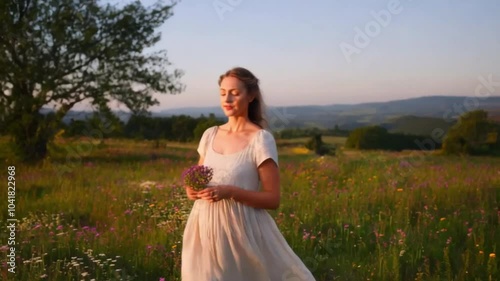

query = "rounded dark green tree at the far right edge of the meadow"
[{"left": 443, "top": 110, "right": 499, "bottom": 154}]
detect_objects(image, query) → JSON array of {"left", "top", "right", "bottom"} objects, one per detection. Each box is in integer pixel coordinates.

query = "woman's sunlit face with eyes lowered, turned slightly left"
[{"left": 220, "top": 77, "right": 253, "bottom": 117}]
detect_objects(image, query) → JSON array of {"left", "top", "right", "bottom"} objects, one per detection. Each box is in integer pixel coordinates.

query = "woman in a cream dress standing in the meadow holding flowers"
[{"left": 182, "top": 67, "right": 314, "bottom": 281}]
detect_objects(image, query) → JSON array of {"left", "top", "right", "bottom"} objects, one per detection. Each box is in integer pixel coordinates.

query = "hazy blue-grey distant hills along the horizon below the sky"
[{"left": 42, "top": 96, "right": 500, "bottom": 134}]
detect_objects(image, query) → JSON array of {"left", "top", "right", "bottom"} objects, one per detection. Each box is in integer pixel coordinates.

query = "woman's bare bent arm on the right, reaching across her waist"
[{"left": 198, "top": 159, "right": 280, "bottom": 210}]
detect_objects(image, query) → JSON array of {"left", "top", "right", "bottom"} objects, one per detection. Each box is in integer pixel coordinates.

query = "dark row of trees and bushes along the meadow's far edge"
[{"left": 51, "top": 110, "right": 500, "bottom": 154}]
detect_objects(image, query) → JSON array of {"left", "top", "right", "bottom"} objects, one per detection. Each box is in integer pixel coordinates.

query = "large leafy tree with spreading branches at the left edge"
[{"left": 0, "top": 0, "right": 184, "bottom": 160}]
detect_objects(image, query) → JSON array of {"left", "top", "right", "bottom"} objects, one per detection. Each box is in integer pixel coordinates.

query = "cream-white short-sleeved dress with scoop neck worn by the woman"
[{"left": 181, "top": 126, "right": 315, "bottom": 281}]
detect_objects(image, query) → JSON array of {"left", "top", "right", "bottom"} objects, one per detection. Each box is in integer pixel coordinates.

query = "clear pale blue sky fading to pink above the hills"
[{"left": 86, "top": 0, "right": 500, "bottom": 111}]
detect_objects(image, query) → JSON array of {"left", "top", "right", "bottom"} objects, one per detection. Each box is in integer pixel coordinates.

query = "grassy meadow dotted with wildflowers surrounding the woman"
[{"left": 0, "top": 139, "right": 500, "bottom": 281}]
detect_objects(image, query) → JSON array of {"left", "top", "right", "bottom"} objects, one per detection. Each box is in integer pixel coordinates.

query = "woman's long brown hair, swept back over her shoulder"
[{"left": 219, "top": 67, "right": 269, "bottom": 129}]
